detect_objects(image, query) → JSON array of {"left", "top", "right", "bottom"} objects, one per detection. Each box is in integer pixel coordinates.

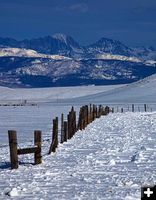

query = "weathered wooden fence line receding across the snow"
[{"left": 8, "top": 104, "right": 150, "bottom": 169}]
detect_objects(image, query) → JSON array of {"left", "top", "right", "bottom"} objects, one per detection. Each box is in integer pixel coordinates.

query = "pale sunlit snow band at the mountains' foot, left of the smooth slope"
[{"left": 0, "top": 85, "right": 122, "bottom": 102}]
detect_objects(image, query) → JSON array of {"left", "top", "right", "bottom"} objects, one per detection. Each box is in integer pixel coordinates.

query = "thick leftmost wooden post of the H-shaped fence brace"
[{"left": 8, "top": 130, "right": 18, "bottom": 169}]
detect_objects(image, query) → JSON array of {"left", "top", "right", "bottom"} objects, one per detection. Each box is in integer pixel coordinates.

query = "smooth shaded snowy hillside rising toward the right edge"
[{"left": 71, "top": 74, "right": 156, "bottom": 104}]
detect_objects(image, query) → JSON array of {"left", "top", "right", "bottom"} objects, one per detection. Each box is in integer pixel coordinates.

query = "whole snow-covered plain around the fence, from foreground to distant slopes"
[{"left": 0, "top": 76, "right": 156, "bottom": 200}]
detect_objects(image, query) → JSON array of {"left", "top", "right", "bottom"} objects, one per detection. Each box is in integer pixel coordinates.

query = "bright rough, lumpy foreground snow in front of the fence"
[{"left": 0, "top": 112, "right": 156, "bottom": 200}]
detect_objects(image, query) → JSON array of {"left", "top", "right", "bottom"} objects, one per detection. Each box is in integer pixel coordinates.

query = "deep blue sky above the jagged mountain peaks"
[{"left": 0, "top": 0, "right": 156, "bottom": 47}]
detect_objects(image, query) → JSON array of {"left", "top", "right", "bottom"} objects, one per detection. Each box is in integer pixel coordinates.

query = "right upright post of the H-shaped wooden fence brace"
[{"left": 34, "top": 130, "right": 42, "bottom": 165}]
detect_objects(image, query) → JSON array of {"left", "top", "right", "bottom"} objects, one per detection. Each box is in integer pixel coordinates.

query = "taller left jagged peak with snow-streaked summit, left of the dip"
[{"left": 0, "top": 34, "right": 83, "bottom": 57}]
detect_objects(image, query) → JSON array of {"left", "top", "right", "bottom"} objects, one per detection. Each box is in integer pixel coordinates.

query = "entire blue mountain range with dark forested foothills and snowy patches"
[{"left": 0, "top": 34, "right": 156, "bottom": 87}]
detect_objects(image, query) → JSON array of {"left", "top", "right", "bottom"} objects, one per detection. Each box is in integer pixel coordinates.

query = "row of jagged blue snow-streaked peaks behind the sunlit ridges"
[{"left": 0, "top": 34, "right": 156, "bottom": 60}]
